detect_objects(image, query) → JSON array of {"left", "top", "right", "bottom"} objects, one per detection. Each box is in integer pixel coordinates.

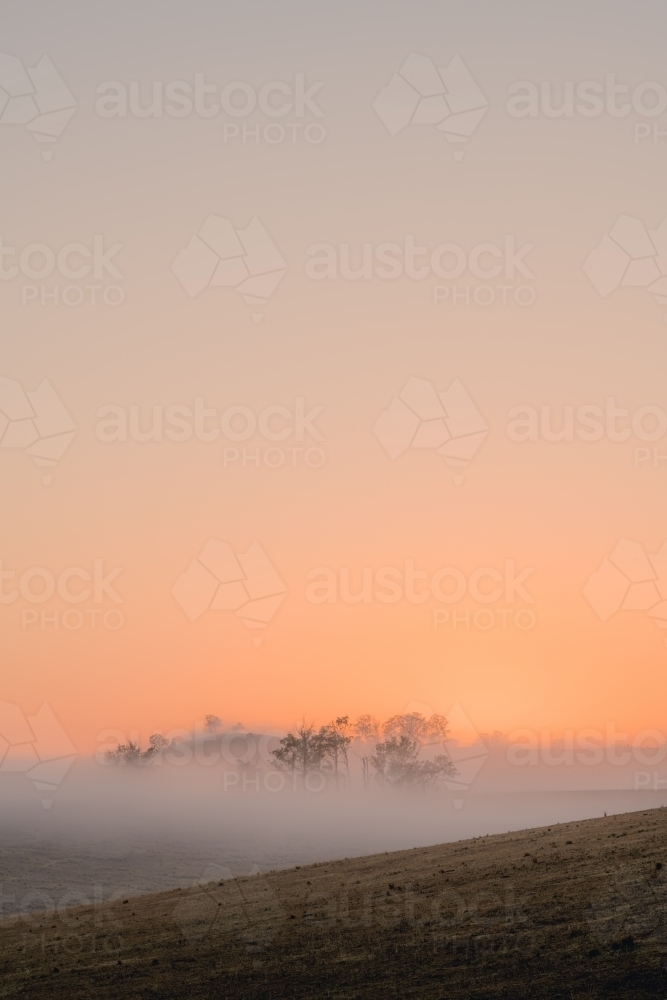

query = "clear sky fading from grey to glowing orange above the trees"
[{"left": 0, "top": 0, "right": 667, "bottom": 752}]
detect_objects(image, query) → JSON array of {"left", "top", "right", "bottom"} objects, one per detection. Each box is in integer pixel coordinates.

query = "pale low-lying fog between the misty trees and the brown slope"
[{"left": 0, "top": 734, "right": 667, "bottom": 916}]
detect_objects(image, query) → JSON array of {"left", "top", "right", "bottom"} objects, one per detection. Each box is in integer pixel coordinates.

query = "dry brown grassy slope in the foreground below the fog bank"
[{"left": 0, "top": 799, "right": 667, "bottom": 1000}]
